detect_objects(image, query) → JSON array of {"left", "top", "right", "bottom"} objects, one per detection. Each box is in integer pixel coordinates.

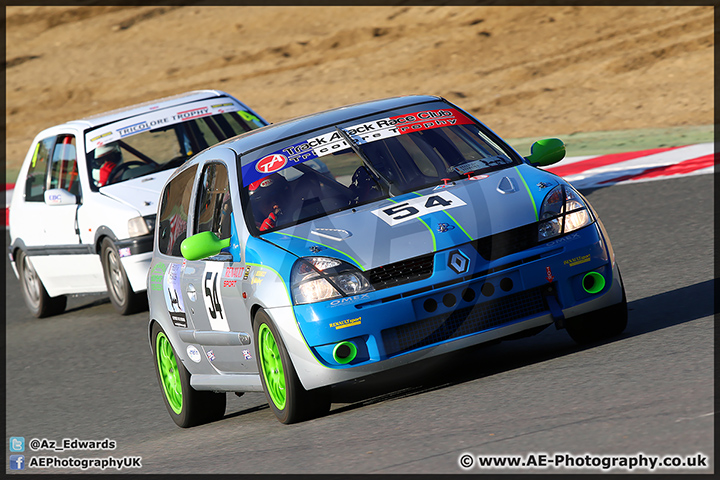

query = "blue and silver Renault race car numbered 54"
[{"left": 147, "top": 96, "right": 627, "bottom": 427}]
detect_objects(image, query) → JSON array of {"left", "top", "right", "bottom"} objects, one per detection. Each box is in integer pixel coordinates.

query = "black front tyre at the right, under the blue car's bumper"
[{"left": 565, "top": 269, "right": 628, "bottom": 345}]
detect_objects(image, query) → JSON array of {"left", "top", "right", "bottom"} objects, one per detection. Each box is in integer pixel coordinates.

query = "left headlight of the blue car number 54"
[{"left": 290, "top": 257, "right": 375, "bottom": 305}]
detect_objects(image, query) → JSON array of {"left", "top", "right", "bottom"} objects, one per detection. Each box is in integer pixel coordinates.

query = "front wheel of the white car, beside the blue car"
[{"left": 100, "top": 237, "right": 147, "bottom": 315}]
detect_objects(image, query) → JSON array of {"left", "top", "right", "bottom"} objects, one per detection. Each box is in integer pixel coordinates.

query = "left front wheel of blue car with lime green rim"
[{"left": 253, "top": 310, "right": 330, "bottom": 424}]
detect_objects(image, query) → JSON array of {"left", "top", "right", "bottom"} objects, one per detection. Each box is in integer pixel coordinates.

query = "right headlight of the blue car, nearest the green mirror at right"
[{"left": 538, "top": 185, "right": 593, "bottom": 241}]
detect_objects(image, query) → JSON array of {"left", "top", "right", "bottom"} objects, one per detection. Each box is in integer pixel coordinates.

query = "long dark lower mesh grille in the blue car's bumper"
[{"left": 382, "top": 287, "right": 548, "bottom": 356}]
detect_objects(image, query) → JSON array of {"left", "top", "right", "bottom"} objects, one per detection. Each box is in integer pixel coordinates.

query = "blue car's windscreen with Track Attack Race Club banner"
[{"left": 241, "top": 107, "right": 519, "bottom": 234}]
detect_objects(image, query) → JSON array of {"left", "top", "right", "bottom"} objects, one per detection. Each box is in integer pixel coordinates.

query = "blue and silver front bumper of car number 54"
[{"left": 269, "top": 224, "right": 622, "bottom": 389}]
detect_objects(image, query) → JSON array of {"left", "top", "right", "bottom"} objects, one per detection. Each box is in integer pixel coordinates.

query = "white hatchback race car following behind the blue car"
[{"left": 8, "top": 90, "right": 267, "bottom": 317}]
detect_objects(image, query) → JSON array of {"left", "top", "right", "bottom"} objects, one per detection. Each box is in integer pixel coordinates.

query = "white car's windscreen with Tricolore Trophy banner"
[{"left": 85, "top": 98, "right": 265, "bottom": 189}]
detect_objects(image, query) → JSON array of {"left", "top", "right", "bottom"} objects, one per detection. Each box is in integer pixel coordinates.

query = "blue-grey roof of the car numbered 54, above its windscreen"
[{"left": 220, "top": 95, "right": 444, "bottom": 155}]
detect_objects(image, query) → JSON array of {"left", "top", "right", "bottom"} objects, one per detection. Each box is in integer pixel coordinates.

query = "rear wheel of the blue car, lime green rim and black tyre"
[{"left": 151, "top": 322, "right": 222, "bottom": 428}]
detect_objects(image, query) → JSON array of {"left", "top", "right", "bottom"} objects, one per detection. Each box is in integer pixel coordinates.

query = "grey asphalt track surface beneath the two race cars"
[{"left": 6, "top": 175, "right": 714, "bottom": 474}]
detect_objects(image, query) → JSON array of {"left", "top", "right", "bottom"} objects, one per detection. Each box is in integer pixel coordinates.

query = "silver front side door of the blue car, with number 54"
[{"left": 182, "top": 162, "right": 257, "bottom": 373}]
